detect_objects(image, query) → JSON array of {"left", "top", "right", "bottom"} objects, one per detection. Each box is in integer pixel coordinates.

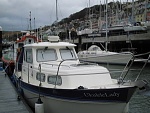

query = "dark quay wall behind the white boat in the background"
[{"left": 67, "top": 30, "right": 150, "bottom": 54}]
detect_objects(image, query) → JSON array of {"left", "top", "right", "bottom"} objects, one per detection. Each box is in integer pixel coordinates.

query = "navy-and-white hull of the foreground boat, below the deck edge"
[{"left": 18, "top": 82, "right": 136, "bottom": 113}]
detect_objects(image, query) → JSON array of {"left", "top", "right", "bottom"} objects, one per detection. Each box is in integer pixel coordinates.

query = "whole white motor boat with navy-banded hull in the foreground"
[{"left": 14, "top": 36, "right": 148, "bottom": 113}]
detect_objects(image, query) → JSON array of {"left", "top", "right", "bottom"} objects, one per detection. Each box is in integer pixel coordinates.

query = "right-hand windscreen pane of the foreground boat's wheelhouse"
[{"left": 60, "top": 48, "right": 76, "bottom": 60}]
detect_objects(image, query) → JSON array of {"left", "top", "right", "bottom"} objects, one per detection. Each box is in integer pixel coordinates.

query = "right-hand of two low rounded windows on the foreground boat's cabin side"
[{"left": 47, "top": 75, "right": 62, "bottom": 86}]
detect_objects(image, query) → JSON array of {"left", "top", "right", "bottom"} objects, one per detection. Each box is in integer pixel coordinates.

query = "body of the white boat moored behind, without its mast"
[{"left": 78, "top": 45, "right": 133, "bottom": 65}]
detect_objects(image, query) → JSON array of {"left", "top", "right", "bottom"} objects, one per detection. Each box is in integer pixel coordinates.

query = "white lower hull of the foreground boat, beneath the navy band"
[{"left": 24, "top": 90, "right": 128, "bottom": 113}]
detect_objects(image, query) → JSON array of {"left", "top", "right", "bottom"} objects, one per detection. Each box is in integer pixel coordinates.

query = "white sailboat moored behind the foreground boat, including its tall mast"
[{"left": 78, "top": 1, "right": 133, "bottom": 65}]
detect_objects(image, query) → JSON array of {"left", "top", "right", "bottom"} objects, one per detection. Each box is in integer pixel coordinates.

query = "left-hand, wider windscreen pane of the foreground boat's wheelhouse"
[{"left": 36, "top": 49, "right": 57, "bottom": 62}]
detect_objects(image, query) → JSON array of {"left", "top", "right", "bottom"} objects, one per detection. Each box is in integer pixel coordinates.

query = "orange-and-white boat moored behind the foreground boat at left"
[{"left": 2, "top": 32, "right": 40, "bottom": 76}]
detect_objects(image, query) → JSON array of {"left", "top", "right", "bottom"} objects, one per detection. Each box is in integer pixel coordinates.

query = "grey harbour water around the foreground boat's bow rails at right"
[{"left": 103, "top": 64, "right": 150, "bottom": 113}]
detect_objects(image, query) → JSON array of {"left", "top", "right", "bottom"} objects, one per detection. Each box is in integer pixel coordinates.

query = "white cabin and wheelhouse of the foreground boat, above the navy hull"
[{"left": 18, "top": 37, "right": 112, "bottom": 88}]
